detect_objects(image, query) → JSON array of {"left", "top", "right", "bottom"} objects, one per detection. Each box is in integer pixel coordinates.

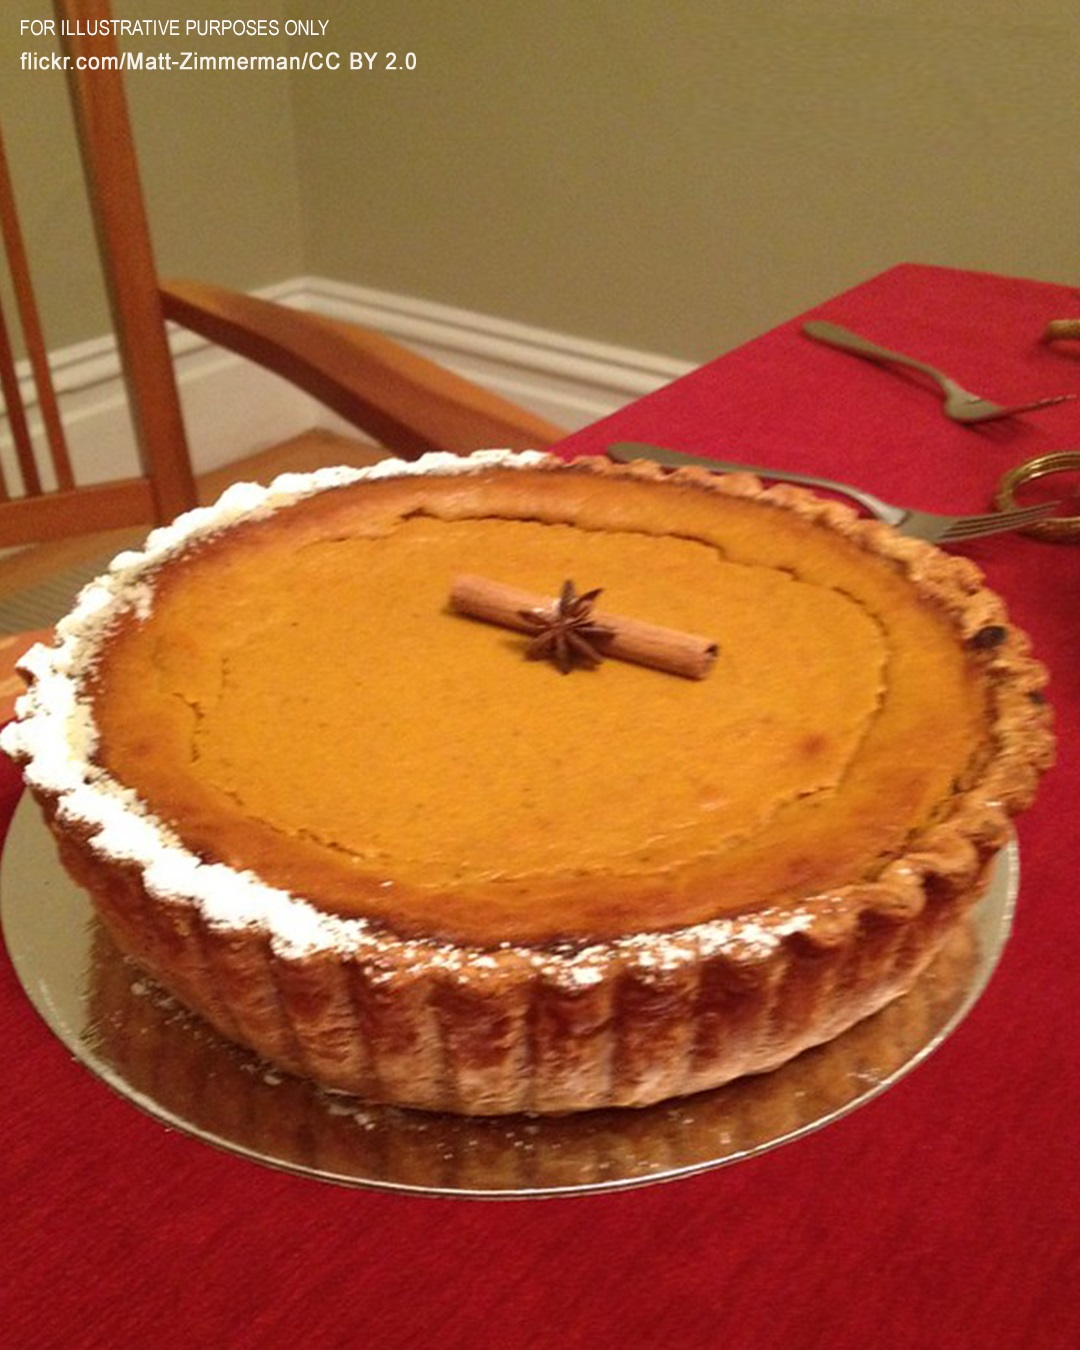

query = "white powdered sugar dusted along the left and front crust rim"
[{"left": 0, "top": 451, "right": 810, "bottom": 972}]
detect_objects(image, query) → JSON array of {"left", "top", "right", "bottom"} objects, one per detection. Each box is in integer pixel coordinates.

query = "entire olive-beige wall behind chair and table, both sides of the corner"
[{"left": 0, "top": 0, "right": 1080, "bottom": 359}]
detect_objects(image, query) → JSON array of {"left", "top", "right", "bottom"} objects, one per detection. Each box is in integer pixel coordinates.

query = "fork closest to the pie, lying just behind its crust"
[{"left": 608, "top": 441, "right": 1057, "bottom": 544}]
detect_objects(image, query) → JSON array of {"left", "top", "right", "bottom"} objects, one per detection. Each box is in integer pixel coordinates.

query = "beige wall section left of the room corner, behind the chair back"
[{"left": 0, "top": 0, "right": 305, "bottom": 346}]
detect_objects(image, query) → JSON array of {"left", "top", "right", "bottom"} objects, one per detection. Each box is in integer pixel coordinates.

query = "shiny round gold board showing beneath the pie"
[{"left": 0, "top": 795, "right": 1019, "bottom": 1199}]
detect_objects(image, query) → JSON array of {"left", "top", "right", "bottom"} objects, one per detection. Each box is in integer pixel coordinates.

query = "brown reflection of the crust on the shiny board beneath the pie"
[{"left": 89, "top": 922, "right": 979, "bottom": 1193}]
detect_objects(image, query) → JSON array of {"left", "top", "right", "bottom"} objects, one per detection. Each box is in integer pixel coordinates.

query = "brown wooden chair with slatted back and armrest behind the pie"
[{"left": 0, "top": 0, "right": 562, "bottom": 548}]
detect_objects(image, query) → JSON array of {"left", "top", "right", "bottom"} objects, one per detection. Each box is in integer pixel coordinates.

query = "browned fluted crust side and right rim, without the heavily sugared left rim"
[{"left": 6, "top": 460, "right": 1053, "bottom": 1114}]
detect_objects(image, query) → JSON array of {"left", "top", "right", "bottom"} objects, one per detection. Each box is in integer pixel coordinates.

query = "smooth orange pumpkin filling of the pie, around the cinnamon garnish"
[{"left": 96, "top": 474, "right": 987, "bottom": 944}]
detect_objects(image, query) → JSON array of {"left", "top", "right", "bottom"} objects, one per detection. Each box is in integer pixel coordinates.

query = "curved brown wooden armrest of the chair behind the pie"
[{"left": 161, "top": 281, "right": 566, "bottom": 456}]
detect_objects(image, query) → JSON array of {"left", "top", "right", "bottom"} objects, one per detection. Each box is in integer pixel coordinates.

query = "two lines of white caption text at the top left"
[{"left": 19, "top": 19, "right": 417, "bottom": 73}]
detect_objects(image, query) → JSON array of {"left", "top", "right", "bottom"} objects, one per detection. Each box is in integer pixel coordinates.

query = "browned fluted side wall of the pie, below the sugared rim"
[{"left": 40, "top": 788, "right": 981, "bottom": 1115}]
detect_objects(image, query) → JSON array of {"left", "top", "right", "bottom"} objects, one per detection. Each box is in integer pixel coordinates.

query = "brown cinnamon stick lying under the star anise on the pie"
[{"left": 450, "top": 575, "right": 718, "bottom": 679}]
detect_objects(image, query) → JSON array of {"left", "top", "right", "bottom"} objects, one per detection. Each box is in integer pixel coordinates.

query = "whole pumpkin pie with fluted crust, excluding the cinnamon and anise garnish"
[{"left": 0, "top": 451, "right": 1053, "bottom": 1115}]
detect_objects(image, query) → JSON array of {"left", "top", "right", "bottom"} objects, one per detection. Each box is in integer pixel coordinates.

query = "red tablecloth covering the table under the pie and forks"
[{"left": 0, "top": 266, "right": 1080, "bottom": 1350}]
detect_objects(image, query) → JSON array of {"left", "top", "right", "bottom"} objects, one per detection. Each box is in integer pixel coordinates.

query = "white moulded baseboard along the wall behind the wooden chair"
[{"left": 0, "top": 277, "right": 691, "bottom": 490}]
